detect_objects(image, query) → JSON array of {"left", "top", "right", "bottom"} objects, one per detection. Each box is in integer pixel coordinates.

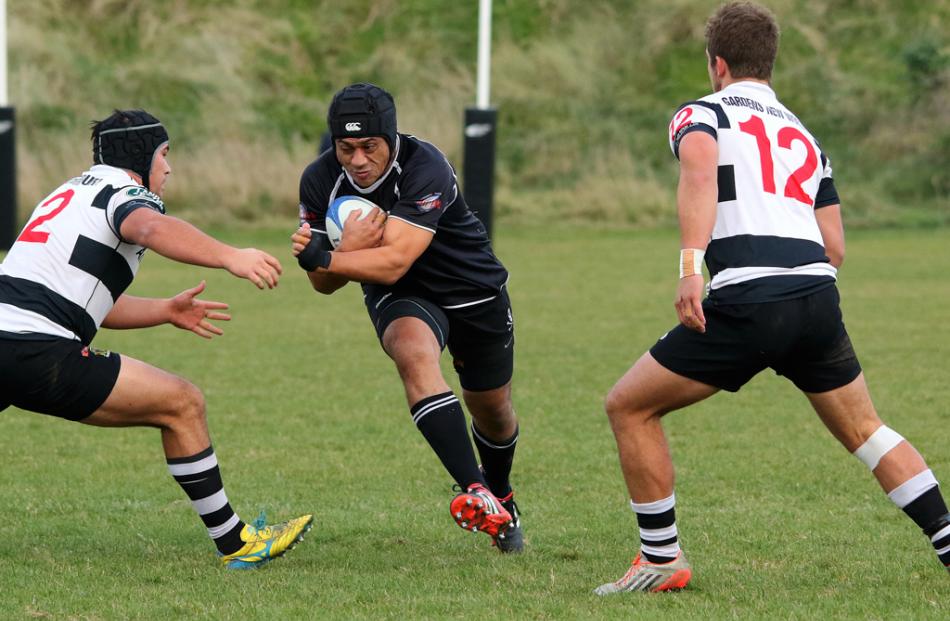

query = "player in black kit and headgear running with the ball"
[{"left": 291, "top": 83, "right": 524, "bottom": 552}]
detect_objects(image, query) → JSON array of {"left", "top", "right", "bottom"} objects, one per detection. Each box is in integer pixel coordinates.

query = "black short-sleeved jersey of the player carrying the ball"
[{"left": 300, "top": 134, "right": 508, "bottom": 308}]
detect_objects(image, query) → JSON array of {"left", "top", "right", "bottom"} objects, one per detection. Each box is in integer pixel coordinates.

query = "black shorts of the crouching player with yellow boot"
[{"left": 0, "top": 339, "right": 122, "bottom": 421}]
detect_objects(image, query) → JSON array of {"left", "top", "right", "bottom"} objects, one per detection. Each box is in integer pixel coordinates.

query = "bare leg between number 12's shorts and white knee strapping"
[{"left": 805, "top": 373, "right": 882, "bottom": 453}]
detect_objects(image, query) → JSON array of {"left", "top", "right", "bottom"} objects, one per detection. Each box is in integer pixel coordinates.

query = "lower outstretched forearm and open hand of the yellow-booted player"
[{"left": 102, "top": 280, "right": 231, "bottom": 339}]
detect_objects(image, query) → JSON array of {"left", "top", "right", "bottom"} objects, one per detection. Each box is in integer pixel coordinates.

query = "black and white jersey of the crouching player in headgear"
[{"left": 0, "top": 165, "right": 165, "bottom": 345}]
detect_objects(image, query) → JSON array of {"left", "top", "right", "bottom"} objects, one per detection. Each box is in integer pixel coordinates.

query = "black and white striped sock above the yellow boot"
[{"left": 167, "top": 446, "right": 244, "bottom": 554}]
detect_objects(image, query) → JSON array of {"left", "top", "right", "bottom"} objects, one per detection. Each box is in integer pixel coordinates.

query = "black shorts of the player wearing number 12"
[{"left": 650, "top": 285, "right": 861, "bottom": 392}]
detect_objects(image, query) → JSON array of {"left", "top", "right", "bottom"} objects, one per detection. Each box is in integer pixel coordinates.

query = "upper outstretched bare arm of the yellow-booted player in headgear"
[{"left": 120, "top": 209, "right": 282, "bottom": 289}]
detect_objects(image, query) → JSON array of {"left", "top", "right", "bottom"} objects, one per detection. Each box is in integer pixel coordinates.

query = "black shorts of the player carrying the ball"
[{"left": 366, "top": 289, "right": 515, "bottom": 392}]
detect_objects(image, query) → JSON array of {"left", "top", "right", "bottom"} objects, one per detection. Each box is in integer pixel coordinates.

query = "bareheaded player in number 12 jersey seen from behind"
[{"left": 595, "top": 3, "right": 950, "bottom": 595}]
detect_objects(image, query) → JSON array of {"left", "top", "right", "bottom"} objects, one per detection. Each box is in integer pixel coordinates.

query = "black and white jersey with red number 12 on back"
[{"left": 669, "top": 81, "right": 838, "bottom": 304}]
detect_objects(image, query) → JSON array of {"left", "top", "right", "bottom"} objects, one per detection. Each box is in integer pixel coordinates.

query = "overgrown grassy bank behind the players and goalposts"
[{"left": 7, "top": 0, "right": 950, "bottom": 226}]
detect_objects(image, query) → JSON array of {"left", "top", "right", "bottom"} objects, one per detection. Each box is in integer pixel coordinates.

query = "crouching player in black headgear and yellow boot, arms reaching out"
[{"left": 0, "top": 110, "right": 312, "bottom": 569}]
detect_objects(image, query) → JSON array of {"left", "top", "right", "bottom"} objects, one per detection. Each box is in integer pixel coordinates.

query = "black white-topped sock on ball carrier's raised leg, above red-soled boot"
[{"left": 409, "top": 392, "right": 485, "bottom": 489}]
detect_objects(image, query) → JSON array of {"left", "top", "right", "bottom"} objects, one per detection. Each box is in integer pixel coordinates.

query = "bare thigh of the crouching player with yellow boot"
[{"left": 82, "top": 356, "right": 204, "bottom": 427}]
